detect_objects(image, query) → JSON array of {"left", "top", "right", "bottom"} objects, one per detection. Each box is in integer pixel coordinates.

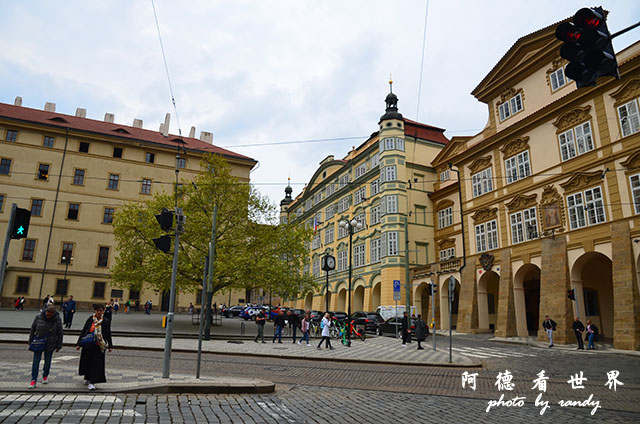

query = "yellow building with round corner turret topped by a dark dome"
[{"left": 281, "top": 88, "right": 448, "bottom": 312}]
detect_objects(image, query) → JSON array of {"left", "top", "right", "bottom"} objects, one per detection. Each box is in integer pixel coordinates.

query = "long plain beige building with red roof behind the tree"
[{"left": 0, "top": 97, "right": 256, "bottom": 310}]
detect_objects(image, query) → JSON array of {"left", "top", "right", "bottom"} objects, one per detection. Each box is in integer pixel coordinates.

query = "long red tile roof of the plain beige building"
[{"left": 0, "top": 103, "right": 256, "bottom": 162}]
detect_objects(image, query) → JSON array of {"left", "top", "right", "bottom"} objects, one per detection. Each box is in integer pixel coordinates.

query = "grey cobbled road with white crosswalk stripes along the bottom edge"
[{"left": 0, "top": 385, "right": 640, "bottom": 423}]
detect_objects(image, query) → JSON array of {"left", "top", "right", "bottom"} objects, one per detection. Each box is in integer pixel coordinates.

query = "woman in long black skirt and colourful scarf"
[{"left": 76, "top": 305, "right": 113, "bottom": 390}]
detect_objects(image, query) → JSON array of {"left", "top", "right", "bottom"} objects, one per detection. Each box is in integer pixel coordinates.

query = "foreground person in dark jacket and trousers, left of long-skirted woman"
[{"left": 29, "top": 305, "right": 62, "bottom": 389}]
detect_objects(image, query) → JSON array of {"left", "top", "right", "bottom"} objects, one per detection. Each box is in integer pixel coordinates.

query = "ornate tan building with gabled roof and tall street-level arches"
[{"left": 412, "top": 19, "right": 640, "bottom": 350}]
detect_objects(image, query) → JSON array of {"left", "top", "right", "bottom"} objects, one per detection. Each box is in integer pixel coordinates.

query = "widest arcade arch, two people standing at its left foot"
[{"left": 571, "top": 252, "right": 614, "bottom": 339}]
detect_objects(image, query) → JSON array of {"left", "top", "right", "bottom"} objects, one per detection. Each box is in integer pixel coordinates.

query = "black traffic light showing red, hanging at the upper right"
[{"left": 556, "top": 7, "right": 620, "bottom": 87}]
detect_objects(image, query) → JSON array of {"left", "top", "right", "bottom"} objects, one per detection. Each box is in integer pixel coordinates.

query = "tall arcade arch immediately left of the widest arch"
[{"left": 513, "top": 264, "right": 541, "bottom": 337}]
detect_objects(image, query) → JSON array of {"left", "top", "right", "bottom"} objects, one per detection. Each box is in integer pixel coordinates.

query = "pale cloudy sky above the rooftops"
[{"left": 0, "top": 0, "right": 640, "bottom": 209}]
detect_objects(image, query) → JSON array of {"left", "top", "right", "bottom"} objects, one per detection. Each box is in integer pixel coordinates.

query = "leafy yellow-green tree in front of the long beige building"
[{"left": 111, "top": 155, "right": 313, "bottom": 294}]
